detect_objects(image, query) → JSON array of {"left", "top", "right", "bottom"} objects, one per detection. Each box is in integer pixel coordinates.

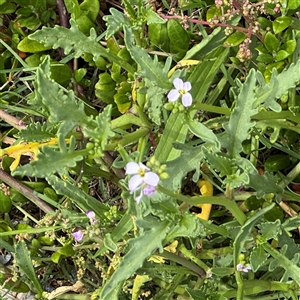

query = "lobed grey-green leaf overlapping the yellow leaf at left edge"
[{"left": 13, "top": 134, "right": 83, "bottom": 178}]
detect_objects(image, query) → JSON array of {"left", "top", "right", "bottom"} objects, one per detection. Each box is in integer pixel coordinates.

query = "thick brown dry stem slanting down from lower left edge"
[{"left": 0, "top": 169, "right": 53, "bottom": 213}]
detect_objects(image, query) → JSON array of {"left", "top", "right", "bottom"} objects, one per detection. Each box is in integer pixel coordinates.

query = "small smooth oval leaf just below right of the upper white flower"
[{"left": 186, "top": 118, "right": 221, "bottom": 150}]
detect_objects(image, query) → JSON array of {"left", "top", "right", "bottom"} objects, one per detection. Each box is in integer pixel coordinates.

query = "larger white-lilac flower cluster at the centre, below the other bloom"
[{"left": 126, "top": 162, "right": 159, "bottom": 203}]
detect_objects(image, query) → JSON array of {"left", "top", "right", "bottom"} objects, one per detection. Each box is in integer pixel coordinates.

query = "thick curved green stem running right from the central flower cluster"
[{"left": 157, "top": 186, "right": 247, "bottom": 225}]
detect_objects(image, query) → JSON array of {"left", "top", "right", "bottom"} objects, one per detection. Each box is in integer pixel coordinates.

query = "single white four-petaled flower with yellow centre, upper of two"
[{"left": 167, "top": 78, "right": 193, "bottom": 107}]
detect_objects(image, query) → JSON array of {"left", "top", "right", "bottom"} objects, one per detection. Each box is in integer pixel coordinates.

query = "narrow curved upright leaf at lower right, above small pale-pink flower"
[{"left": 233, "top": 203, "right": 275, "bottom": 266}]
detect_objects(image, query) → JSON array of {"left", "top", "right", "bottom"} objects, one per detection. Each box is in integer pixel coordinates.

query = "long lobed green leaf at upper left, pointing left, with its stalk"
[{"left": 28, "top": 19, "right": 134, "bottom": 73}]
